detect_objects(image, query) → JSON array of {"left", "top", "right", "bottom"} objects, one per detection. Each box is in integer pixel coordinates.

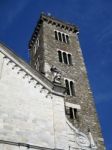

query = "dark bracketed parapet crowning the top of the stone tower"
[{"left": 29, "top": 12, "right": 79, "bottom": 48}]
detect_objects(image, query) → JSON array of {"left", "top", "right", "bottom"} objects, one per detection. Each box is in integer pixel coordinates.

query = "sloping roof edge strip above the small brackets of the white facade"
[{"left": 0, "top": 43, "right": 65, "bottom": 97}]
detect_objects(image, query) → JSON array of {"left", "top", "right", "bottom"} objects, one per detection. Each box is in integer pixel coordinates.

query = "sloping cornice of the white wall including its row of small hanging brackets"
[{"left": 0, "top": 43, "right": 65, "bottom": 97}]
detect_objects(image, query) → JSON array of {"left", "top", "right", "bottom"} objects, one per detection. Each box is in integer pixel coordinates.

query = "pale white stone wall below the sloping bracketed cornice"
[{"left": 0, "top": 53, "right": 67, "bottom": 150}]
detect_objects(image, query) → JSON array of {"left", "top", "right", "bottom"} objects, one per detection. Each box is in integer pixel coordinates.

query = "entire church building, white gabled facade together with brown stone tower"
[{"left": 0, "top": 14, "right": 105, "bottom": 150}]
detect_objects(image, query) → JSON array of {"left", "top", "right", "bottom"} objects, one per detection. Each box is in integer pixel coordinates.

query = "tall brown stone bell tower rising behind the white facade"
[{"left": 29, "top": 14, "right": 104, "bottom": 150}]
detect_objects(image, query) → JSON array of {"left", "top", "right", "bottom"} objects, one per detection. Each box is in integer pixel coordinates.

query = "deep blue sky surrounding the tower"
[{"left": 0, "top": 0, "right": 112, "bottom": 150}]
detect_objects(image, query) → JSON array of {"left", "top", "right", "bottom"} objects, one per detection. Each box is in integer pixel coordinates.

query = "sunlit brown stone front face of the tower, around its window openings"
[{"left": 43, "top": 22, "right": 104, "bottom": 150}]
